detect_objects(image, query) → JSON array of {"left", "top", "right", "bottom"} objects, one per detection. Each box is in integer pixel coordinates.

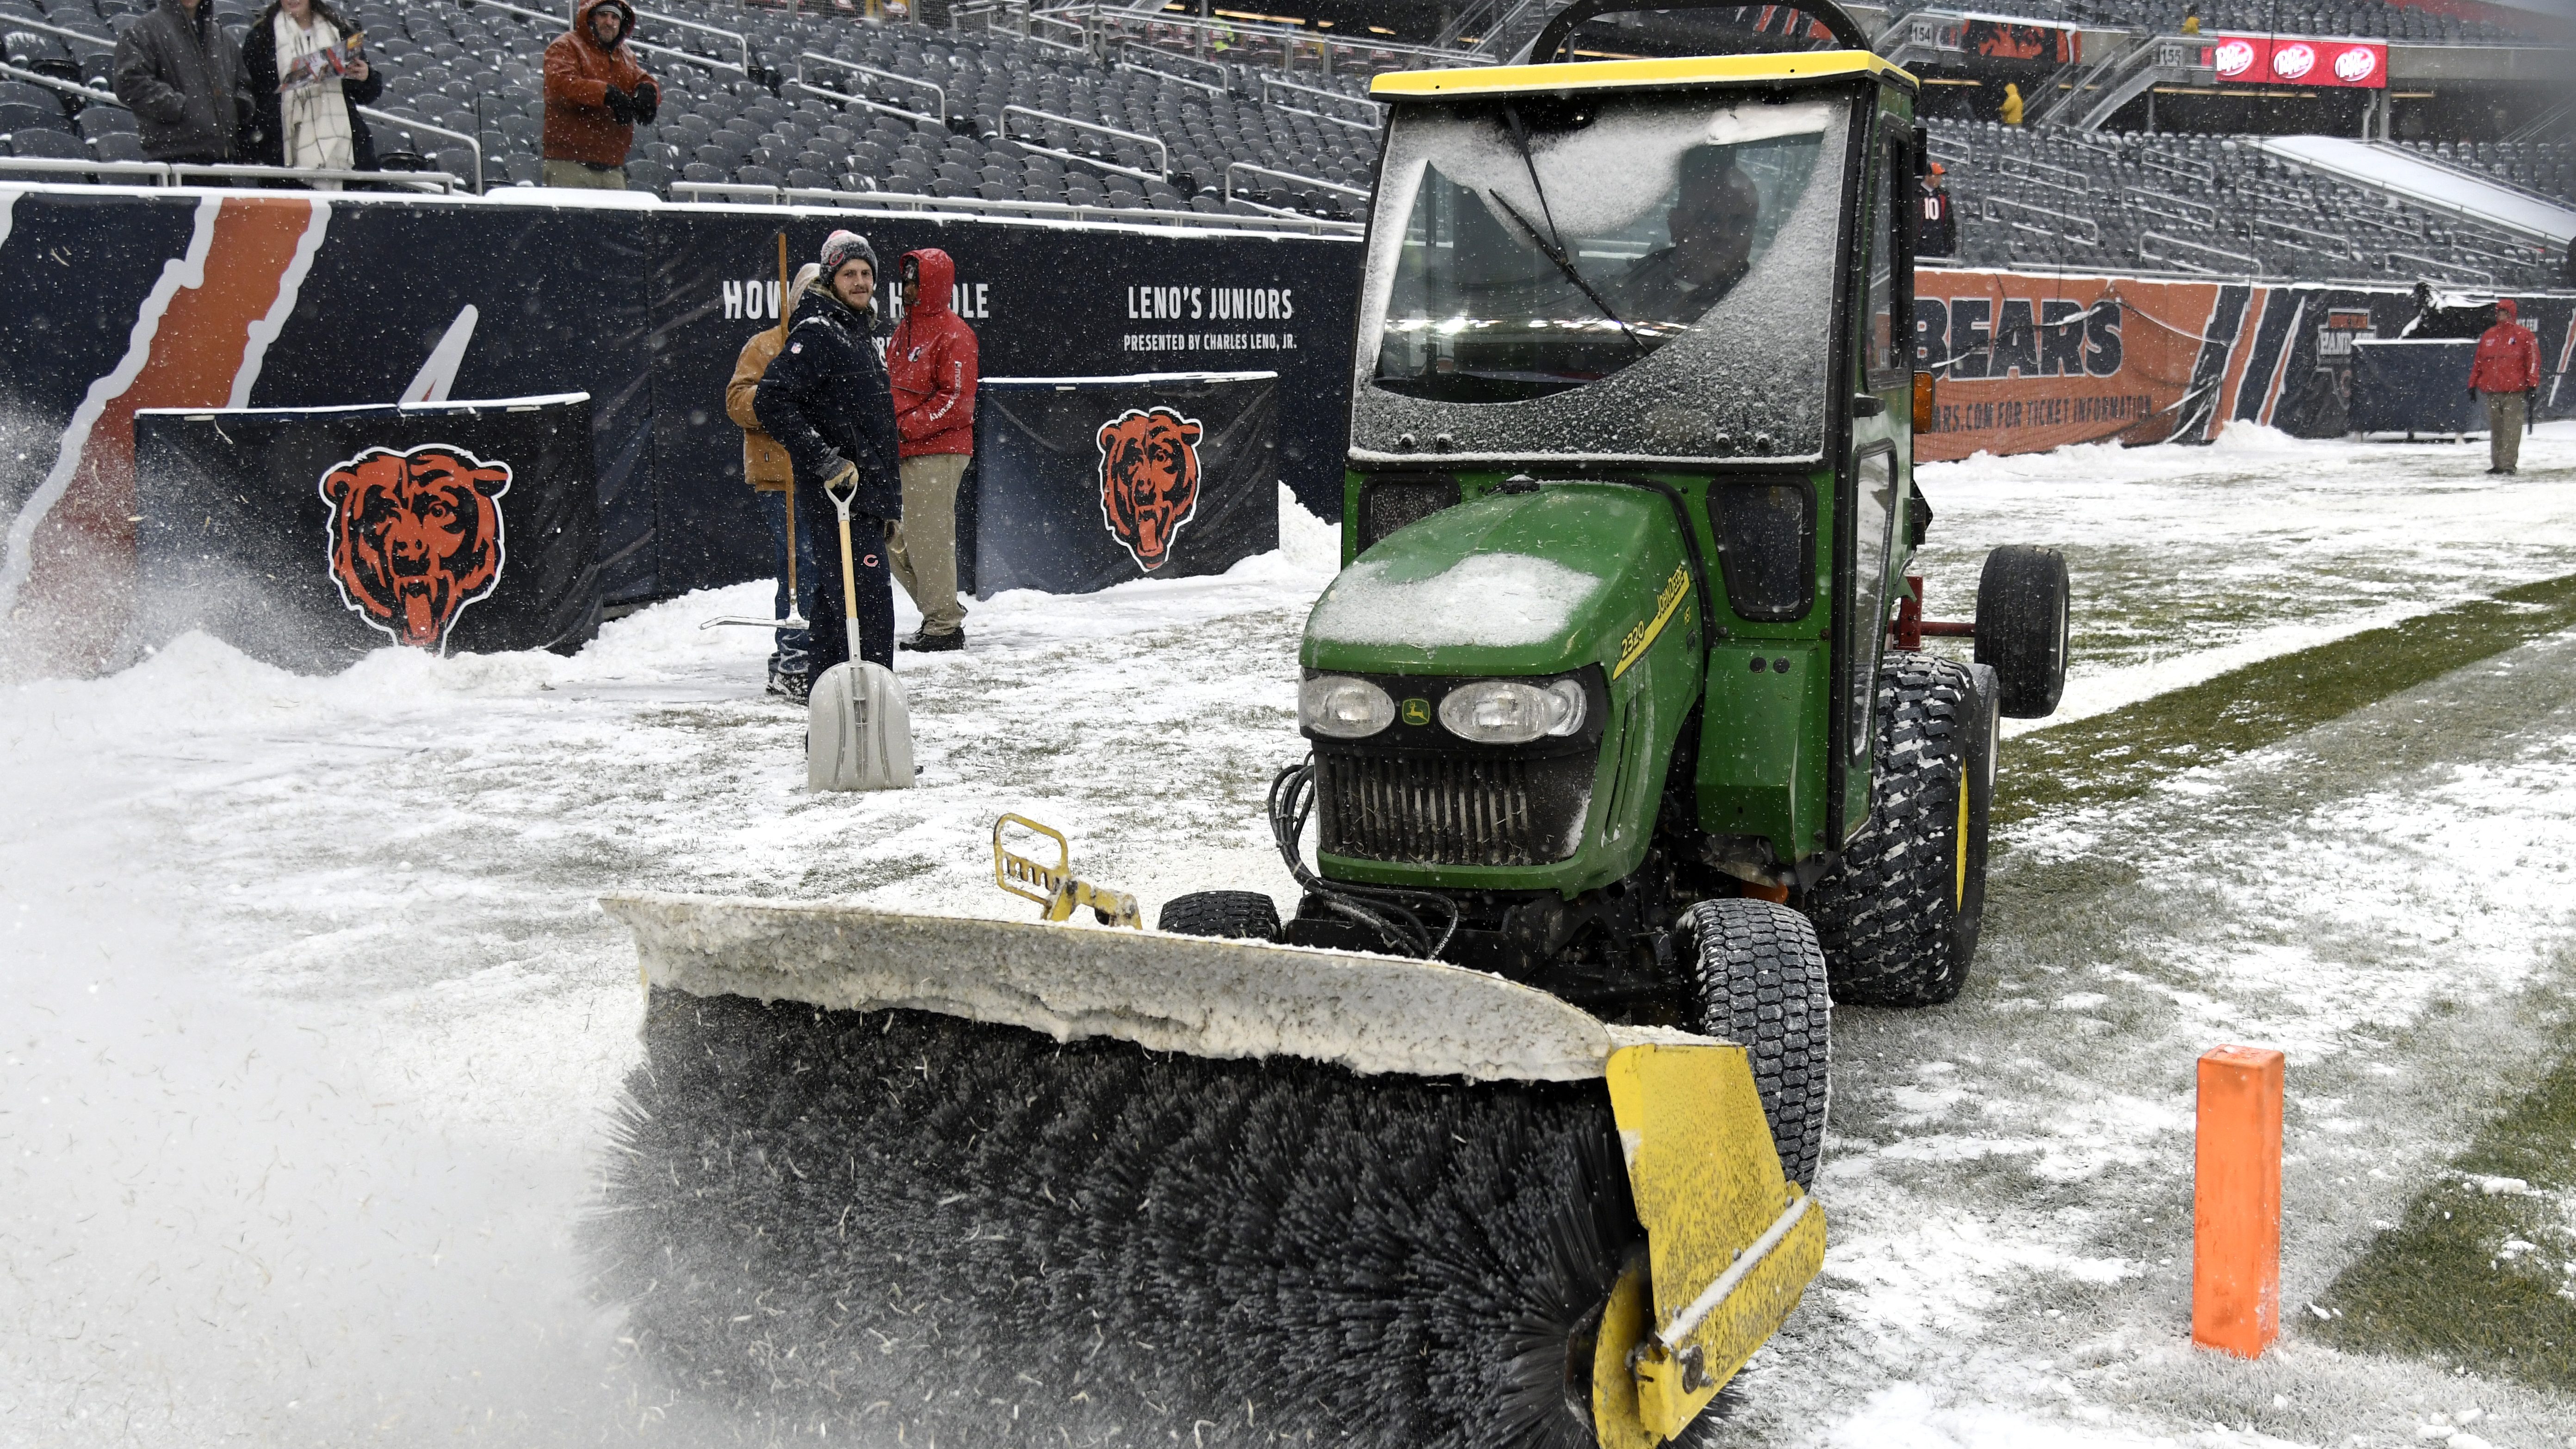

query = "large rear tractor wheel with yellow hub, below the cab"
[{"left": 1798, "top": 655, "right": 2006, "bottom": 1005}]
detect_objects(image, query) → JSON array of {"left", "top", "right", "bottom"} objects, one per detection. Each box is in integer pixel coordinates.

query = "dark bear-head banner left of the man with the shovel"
[{"left": 134, "top": 395, "right": 600, "bottom": 670}]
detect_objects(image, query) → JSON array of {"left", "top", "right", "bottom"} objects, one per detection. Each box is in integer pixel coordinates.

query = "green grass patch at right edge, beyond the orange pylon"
[{"left": 2313, "top": 1041, "right": 2576, "bottom": 1390}]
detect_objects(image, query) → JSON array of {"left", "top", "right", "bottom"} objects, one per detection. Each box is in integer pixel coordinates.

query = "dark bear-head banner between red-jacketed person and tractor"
[{"left": 958, "top": 372, "right": 1280, "bottom": 598}]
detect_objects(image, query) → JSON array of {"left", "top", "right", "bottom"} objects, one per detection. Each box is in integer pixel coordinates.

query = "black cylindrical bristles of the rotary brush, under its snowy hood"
[{"left": 590, "top": 990, "right": 1710, "bottom": 1449}]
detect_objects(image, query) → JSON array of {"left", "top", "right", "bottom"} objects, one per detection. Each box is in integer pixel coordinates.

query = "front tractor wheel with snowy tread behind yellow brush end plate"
[{"left": 1679, "top": 900, "right": 1834, "bottom": 1186}]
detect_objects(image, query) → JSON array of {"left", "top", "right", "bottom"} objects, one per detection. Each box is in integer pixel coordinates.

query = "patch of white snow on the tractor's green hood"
[{"left": 1306, "top": 554, "right": 1602, "bottom": 650}]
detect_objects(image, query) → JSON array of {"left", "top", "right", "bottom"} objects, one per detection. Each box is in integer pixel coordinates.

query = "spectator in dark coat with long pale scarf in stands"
[{"left": 242, "top": 0, "right": 384, "bottom": 191}]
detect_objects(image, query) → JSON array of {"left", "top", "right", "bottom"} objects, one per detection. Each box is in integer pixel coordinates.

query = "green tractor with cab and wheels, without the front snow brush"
[{"left": 1162, "top": 5, "right": 2068, "bottom": 1181}]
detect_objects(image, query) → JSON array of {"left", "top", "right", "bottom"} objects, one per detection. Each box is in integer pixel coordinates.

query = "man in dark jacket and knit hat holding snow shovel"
[{"left": 752, "top": 232, "right": 904, "bottom": 694}]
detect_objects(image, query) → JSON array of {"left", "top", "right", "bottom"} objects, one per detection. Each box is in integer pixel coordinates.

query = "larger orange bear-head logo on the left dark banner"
[{"left": 322, "top": 444, "right": 510, "bottom": 652}]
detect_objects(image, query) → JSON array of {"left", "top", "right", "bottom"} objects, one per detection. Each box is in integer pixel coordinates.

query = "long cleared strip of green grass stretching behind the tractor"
[{"left": 1994, "top": 575, "right": 2576, "bottom": 825}]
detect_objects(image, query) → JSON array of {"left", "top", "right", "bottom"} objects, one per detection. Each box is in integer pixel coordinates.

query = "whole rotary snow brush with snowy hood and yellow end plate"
[{"left": 585, "top": 897, "right": 1824, "bottom": 1449}]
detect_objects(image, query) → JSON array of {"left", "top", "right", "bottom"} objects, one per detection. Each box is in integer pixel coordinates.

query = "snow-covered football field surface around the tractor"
[{"left": 0, "top": 426, "right": 2576, "bottom": 1449}]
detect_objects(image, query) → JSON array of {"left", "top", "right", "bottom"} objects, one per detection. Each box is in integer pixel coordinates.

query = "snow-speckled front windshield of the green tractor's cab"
[{"left": 1352, "top": 93, "right": 1850, "bottom": 459}]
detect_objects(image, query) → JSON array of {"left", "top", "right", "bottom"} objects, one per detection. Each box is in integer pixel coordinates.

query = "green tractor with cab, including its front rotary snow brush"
[{"left": 590, "top": 0, "right": 2066, "bottom": 1449}]
